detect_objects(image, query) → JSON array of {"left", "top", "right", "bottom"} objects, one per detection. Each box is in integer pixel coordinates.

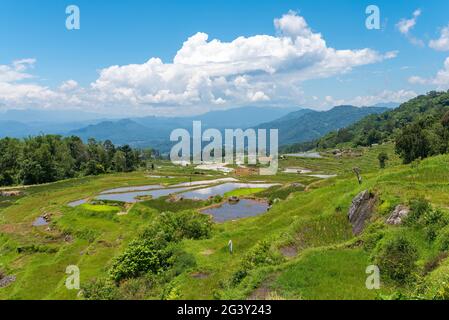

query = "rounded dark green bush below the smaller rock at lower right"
[{"left": 374, "top": 235, "right": 418, "bottom": 284}]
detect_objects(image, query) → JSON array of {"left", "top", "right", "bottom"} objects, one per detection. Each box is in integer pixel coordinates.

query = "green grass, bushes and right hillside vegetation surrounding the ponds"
[{"left": 4, "top": 93, "right": 449, "bottom": 299}]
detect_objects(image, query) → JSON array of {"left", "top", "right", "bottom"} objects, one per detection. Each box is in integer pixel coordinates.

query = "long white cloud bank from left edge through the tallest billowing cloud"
[{"left": 0, "top": 11, "right": 397, "bottom": 112}]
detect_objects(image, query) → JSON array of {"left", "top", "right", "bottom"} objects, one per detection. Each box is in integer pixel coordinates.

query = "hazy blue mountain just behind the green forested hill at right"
[{"left": 258, "top": 106, "right": 388, "bottom": 145}]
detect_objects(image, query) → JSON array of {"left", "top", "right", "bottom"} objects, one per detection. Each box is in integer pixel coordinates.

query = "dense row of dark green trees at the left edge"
[{"left": 0, "top": 135, "right": 152, "bottom": 186}]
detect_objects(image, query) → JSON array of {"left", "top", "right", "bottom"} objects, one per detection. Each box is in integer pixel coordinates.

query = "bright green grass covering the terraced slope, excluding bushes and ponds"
[{"left": 0, "top": 144, "right": 449, "bottom": 299}]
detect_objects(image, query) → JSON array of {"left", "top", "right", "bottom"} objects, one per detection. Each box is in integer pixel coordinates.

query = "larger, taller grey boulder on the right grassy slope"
[{"left": 348, "top": 190, "right": 376, "bottom": 235}]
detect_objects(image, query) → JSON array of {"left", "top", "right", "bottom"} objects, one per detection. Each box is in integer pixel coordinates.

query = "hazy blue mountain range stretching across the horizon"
[{"left": 0, "top": 104, "right": 394, "bottom": 152}]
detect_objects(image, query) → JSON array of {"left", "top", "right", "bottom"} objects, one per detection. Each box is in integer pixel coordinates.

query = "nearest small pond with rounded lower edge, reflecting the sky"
[{"left": 201, "top": 199, "right": 268, "bottom": 222}]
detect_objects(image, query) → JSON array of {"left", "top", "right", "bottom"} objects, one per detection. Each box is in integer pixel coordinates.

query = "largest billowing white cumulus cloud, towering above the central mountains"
[{"left": 92, "top": 12, "right": 396, "bottom": 111}]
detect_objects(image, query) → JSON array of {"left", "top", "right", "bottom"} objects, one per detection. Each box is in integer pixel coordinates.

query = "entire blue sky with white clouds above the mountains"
[{"left": 0, "top": 0, "right": 449, "bottom": 115}]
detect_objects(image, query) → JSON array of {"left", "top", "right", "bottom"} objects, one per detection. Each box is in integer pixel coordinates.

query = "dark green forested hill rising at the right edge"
[{"left": 284, "top": 91, "right": 449, "bottom": 162}]
